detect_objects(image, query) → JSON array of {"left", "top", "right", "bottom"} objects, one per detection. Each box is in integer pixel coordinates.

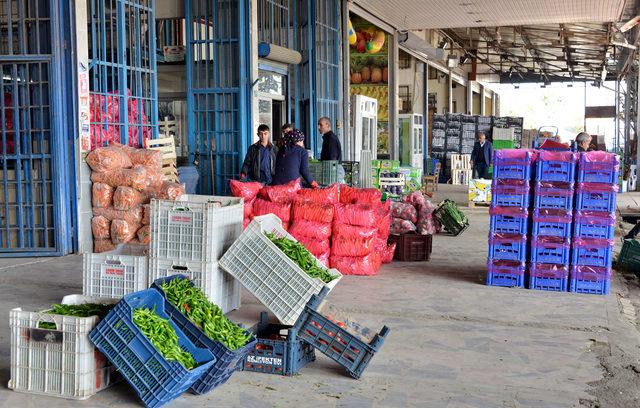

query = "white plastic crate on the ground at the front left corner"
[{"left": 9, "top": 295, "right": 118, "bottom": 400}]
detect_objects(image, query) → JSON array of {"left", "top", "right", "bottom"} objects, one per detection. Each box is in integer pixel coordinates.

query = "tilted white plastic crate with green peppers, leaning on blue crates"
[{"left": 220, "top": 214, "right": 342, "bottom": 326}]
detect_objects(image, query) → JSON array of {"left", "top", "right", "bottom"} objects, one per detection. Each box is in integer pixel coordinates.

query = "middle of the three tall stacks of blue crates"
[{"left": 529, "top": 151, "right": 577, "bottom": 292}]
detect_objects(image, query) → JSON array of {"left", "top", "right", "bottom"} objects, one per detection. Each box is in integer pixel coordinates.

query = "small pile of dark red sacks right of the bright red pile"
[{"left": 391, "top": 191, "right": 436, "bottom": 235}]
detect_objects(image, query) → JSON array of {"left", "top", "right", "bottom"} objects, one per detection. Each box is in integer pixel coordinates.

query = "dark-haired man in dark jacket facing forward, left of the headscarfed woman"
[{"left": 240, "top": 125, "right": 278, "bottom": 185}]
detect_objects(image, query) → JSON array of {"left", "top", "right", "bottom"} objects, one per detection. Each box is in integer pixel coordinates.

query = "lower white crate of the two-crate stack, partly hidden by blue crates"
[{"left": 149, "top": 258, "right": 240, "bottom": 313}]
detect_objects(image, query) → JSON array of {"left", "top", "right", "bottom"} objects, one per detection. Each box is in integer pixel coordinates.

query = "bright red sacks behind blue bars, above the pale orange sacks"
[{"left": 89, "top": 89, "right": 152, "bottom": 149}]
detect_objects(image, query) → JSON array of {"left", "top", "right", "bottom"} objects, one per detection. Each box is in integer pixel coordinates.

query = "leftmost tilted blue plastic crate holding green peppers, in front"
[{"left": 89, "top": 289, "right": 216, "bottom": 407}]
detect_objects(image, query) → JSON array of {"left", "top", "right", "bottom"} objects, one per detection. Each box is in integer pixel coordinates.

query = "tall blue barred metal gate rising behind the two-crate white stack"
[{"left": 185, "top": 0, "right": 251, "bottom": 194}]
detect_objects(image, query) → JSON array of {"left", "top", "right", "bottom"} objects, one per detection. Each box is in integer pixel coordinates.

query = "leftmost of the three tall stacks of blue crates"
[{"left": 487, "top": 149, "right": 536, "bottom": 288}]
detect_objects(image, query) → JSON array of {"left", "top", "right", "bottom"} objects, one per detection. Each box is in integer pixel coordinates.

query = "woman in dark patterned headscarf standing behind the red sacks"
[{"left": 272, "top": 129, "right": 318, "bottom": 188}]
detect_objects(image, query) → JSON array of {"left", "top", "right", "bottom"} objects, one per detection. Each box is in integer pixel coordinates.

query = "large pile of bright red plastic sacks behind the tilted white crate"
[{"left": 231, "top": 180, "right": 395, "bottom": 275}]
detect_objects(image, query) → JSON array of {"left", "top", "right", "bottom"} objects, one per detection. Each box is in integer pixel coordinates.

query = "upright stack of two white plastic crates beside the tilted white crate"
[{"left": 149, "top": 194, "right": 243, "bottom": 313}]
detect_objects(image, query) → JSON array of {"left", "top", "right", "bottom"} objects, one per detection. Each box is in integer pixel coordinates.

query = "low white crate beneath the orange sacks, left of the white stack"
[{"left": 82, "top": 244, "right": 149, "bottom": 299}]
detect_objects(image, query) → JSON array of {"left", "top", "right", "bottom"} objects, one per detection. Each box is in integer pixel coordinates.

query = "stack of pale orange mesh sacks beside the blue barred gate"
[{"left": 87, "top": 144, "right": 185, "bottom": 252}]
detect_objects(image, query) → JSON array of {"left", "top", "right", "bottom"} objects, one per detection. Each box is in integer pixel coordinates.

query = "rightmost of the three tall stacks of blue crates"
[{"left": 570, "top": 151, "right": 620, "bottom": 294}]
